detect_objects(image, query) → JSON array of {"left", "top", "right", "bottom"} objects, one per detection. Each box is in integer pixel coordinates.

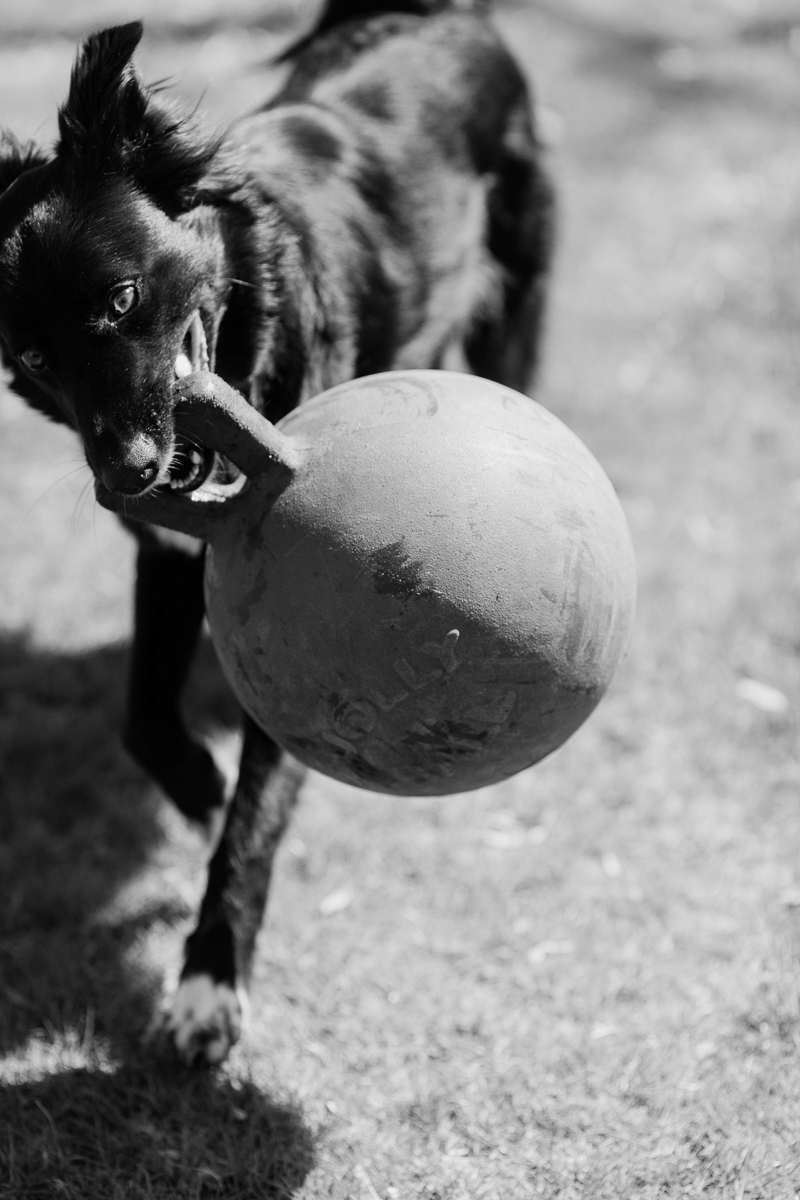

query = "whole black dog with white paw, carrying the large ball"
[{"left": 0, "top": 0, "right": 552, "bottom": 1062}]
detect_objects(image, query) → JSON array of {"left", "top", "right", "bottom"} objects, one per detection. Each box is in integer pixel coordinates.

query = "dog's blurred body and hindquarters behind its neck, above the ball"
[{"left": 219, "top": 0, "right": 552, "bottom": 395}]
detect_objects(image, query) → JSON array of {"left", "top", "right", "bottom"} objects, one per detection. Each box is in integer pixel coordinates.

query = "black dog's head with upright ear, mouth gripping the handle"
[{"left": 0, "top": 23, "right": 236, "bottom": 496}]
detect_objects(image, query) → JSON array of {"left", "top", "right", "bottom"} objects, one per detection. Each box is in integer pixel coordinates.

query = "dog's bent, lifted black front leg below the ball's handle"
[{"left": 122, "top": 538, "right": 225, "bottom": 827}]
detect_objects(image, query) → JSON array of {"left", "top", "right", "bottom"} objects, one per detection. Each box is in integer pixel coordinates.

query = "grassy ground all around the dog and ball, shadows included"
[{"left": 0, "top": 0, "right": 800, "bottom": 1200}]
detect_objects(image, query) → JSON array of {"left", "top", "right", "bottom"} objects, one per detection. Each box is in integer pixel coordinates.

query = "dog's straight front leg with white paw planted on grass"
[{"left": 167, "top": 718, "right": 303, "bottom": 1066}]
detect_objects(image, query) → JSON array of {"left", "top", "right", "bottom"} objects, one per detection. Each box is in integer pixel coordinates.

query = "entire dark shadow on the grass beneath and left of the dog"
[{"left": 0, "top": 637, "right": 313, "bottom": 1198}]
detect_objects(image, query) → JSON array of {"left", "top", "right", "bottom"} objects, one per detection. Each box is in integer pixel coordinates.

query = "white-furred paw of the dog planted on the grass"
[{"left": 166, "top": 974, "right": 247, "bottom": 1067}]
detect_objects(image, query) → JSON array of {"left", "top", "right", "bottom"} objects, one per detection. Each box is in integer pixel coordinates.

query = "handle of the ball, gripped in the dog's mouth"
[{"left": 95, "top": 371, "right": 303, "bottom": 541}]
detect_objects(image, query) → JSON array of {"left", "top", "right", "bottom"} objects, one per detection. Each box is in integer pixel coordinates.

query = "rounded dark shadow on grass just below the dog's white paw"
[{"left": 0, "top": 1066, "right": 313, "bottom": 1200}]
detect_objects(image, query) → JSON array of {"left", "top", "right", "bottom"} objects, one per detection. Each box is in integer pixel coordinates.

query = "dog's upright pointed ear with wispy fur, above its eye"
[{"left": 59, "top": 20, "right": 219, "bottom": 212}]
